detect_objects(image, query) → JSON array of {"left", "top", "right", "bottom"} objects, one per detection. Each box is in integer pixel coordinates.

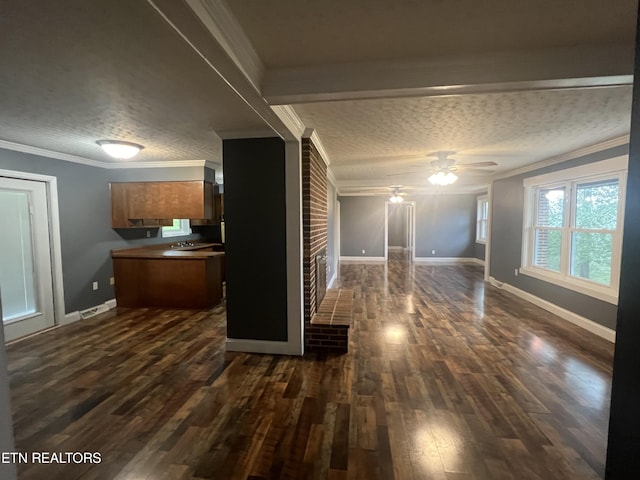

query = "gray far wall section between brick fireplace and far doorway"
[{"left": 340, "top": 197, "right": 387, "bottom": 257}]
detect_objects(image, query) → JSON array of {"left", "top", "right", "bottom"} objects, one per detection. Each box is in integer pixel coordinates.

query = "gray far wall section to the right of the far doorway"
[{"left": 415, "top": 194, "right": 476, "bottom": 258}]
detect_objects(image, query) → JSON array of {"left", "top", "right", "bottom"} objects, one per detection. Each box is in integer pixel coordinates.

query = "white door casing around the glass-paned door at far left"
[{"left": 0, "top": 169, "right": 65, "bottom": 326}]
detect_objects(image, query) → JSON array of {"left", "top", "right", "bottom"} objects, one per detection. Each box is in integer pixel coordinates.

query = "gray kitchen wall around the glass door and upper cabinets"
[{"left": 0, "top": 149, "right": 219, "bottom": 313}]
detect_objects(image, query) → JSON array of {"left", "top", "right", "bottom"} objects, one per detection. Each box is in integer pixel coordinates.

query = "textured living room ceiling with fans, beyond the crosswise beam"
[{"left": 295, "top": 86, "right": 631, "bottom": 192}]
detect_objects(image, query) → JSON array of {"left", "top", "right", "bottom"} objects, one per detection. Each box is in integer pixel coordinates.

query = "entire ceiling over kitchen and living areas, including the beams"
[{"left": 0, "top": 0, "right": 637, "bottom": 194}]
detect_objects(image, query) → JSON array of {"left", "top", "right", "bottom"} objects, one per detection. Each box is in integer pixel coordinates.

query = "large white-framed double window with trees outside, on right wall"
[{"left": 520, "top": 157, "right": 627, "bottom": 304}]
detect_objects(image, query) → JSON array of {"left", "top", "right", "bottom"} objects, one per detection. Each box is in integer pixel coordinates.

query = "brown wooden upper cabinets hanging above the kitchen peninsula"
[{"left": 111, "top": 180, "right": 217, "bottom": 228}]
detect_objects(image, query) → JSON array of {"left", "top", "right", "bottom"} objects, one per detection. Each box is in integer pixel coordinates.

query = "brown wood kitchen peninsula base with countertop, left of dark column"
[{"left": 111, "top": 243, "right": 224, "bottom": 309}]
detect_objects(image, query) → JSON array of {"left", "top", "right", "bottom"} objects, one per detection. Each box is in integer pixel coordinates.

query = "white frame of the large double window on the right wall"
[{"left": 519, "top": 156, "right": 629, "bottom": 305}]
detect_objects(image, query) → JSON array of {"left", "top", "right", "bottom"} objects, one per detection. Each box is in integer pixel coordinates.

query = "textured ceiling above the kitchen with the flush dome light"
[{"left": 0, "top": 0, "right": 265, "bottom": 162}]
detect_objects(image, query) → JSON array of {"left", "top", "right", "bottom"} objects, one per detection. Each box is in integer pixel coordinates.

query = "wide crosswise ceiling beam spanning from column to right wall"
[{"left": 262, "top": 44, "right": 634, "bottom": 105}]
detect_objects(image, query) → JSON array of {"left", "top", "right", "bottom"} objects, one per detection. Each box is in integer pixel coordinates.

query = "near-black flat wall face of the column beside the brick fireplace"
[{"left": 222, "top": 138, "right": 287, "bottom": 342}]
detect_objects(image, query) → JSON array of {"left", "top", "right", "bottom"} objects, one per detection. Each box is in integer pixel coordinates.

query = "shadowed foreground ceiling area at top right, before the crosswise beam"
[{"left": 228, "top": 0, "right": 637, "bottom": 67}]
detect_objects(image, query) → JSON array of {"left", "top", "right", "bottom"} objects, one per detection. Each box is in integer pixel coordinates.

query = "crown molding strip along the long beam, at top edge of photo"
[{"left": 186, "top": 0, "right": 265, "bottom": 92}]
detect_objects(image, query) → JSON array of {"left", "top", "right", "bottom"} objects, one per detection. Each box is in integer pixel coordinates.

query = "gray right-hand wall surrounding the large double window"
[{"left": 490, "top": 145, "right": 629, "bottom": 328}]
